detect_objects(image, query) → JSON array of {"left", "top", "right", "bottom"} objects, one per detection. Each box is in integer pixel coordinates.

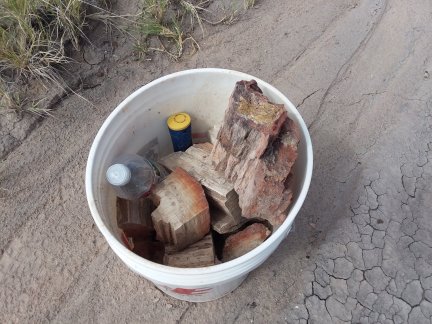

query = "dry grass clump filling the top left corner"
[{"left": 0, "top": 0, "right": 102, "bottom": 114}]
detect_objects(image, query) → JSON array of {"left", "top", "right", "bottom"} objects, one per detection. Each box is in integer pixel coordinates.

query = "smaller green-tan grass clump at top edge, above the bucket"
[{"left": 133, "top": 0, "right": 255, "bottom": 60}]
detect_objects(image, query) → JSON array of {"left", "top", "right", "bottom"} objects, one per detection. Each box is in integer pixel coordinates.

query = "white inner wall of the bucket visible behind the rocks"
[{"left": 87, "top": 70, "right": 307, "bottom": 253}]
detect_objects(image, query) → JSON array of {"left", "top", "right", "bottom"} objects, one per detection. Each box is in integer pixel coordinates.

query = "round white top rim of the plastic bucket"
[{"left": 85, "top": 68, "right": 313, "bottom": 275}]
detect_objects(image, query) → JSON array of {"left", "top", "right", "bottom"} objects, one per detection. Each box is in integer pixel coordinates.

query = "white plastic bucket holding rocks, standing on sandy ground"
[{"left": 86, "top": 69, "right": 313, "bottom": 302}]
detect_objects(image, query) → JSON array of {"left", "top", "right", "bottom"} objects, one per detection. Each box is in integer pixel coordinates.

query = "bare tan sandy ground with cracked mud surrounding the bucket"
[{"left": 0, "top": 0, "right": 432, "bottom": 323}]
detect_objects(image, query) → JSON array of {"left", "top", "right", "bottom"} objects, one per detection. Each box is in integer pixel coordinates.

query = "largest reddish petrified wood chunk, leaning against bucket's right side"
[{"left": 211, "top": 80, "right": 299, "bottom": 228}]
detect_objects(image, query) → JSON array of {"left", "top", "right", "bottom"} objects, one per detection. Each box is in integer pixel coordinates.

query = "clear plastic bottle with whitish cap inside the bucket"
[{"left": 106, "top": 154, "right": 168, "bottom": 200}]
